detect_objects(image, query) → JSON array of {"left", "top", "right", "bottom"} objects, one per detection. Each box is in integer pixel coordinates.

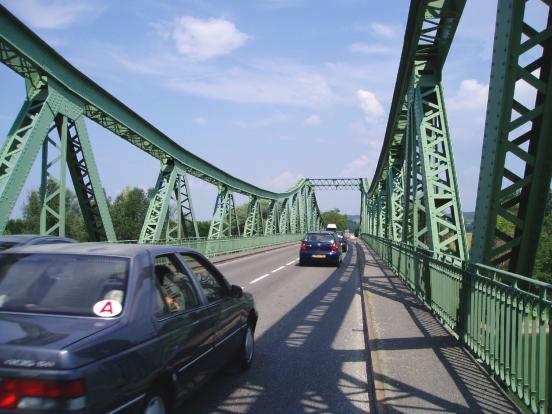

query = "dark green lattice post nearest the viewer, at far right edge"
[{"left": 471, "top": 0, "right": 552, "bottom": 277}]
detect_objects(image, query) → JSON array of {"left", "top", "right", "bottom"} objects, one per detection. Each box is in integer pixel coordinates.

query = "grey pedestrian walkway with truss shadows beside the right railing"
[{"left": 357, "top": 240, "right": 519, "bottom": 414}]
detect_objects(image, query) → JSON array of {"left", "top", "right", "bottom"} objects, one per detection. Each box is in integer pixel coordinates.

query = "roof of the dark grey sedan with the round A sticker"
[{"left": 3, "top": 242, "right": 204, "bottom": 257}]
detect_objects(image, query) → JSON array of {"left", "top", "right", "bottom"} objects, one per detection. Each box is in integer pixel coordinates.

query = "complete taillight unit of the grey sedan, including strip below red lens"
[{"left": 0, "top": 378, "right": 86, "bottom": 411}]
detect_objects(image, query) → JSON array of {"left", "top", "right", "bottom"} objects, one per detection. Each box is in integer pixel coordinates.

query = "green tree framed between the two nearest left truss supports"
[{"left": 110, "top": 187, "right": 151, "bottom": 240}]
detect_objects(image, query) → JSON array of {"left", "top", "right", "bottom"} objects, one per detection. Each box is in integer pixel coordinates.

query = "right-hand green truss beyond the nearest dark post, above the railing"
[{"left": 362, "top": 0, "right": 467, "bottom": 258}]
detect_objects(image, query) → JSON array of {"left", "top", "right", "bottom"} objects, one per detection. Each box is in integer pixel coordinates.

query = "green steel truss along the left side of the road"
[{"left": 0, "top": 6, "right": 328, "bottom": 243}]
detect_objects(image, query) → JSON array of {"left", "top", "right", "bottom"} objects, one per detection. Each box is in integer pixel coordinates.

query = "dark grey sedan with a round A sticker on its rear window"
[{"left": 0, "top": 243, "right": 257, "bottom": 414}]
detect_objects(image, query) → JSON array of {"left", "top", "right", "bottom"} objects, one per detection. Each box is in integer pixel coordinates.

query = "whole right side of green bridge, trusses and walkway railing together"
[{"left": 360, "top": 0, "right": 552, "bottom": 413}]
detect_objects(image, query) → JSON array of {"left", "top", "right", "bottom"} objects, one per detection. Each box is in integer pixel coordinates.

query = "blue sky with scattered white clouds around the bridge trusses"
[{"left": 0, "top": 0, "right": 496, "bottom": 220}]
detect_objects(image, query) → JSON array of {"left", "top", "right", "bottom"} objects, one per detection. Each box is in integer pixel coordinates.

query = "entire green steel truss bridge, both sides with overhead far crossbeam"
[{"left": 0, "top": 0, "right": 552, "bottom": 413}]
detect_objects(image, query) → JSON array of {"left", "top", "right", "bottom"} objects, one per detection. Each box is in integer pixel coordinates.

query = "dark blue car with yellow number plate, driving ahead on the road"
[{"left": 299, "top": 231, "right": 342, "bottom": 266}]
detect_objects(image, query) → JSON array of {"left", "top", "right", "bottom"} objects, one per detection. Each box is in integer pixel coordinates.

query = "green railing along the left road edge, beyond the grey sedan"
[{"left": 115, "top": 233, "right": 304, "bottom": 257}]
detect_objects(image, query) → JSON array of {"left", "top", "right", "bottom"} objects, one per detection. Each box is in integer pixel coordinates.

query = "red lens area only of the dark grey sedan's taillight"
[{"left": 0, "top": 379, "right": 85, "bottom": 408}]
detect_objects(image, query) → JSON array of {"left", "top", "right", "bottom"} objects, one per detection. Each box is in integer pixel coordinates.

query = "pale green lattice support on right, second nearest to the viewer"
[{"left": 410, "top": 65, "right": 467, "bottom": 259}]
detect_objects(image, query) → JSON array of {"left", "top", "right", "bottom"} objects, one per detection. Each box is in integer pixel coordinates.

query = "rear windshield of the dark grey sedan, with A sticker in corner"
[{"left": 0, "top": 253, "right": 129, "bottom": 316}]
